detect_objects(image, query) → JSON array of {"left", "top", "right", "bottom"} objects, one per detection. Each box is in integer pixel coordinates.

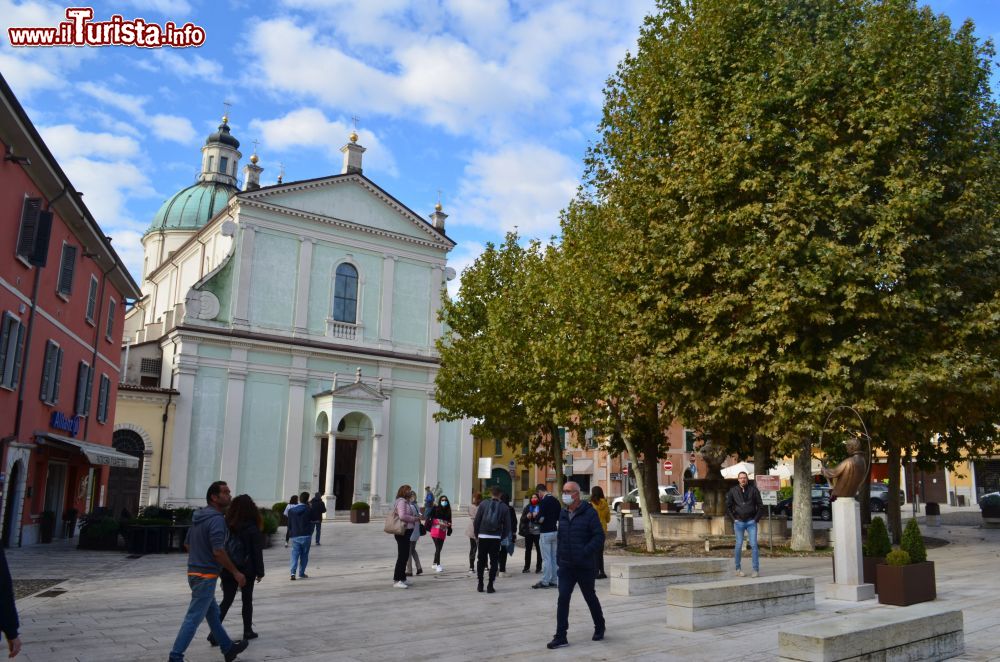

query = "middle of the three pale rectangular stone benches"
[{"left": 667, "top": 575, "right": 816, "bottom": 630}]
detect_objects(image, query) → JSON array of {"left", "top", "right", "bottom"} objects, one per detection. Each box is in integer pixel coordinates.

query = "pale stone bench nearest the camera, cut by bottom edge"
[{"left": 778, "top": 603, "right": 965, "bottom": 662}]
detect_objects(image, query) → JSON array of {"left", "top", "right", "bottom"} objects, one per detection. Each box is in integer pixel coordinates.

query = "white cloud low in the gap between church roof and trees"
[{"left": 452, "top": 145, "right": 578, "bottom": 240}]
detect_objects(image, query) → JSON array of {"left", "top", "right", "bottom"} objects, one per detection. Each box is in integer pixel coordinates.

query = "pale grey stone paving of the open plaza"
[{"left": 8, "top": 513, "right": 1000, "bottom": 662}]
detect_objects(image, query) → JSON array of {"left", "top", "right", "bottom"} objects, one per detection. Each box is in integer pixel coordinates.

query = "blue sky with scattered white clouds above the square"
[{"left": 0, "top": 0, "right": 1000, "bottom": 291}]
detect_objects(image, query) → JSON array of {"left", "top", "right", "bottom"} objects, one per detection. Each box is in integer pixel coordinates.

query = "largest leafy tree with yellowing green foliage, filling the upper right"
[{"left": 589, "top": 0, "right": 1000, "bottom": 547}]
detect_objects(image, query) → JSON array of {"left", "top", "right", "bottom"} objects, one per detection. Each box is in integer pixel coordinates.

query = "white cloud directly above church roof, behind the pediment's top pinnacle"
[{"left": 250, "top": 108, "right": 398, "bottom": 179}]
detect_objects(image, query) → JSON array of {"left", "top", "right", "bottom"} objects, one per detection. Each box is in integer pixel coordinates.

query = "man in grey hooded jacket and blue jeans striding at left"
[{"left": 170, "top": 480, "right": 249, "bottom": 662}]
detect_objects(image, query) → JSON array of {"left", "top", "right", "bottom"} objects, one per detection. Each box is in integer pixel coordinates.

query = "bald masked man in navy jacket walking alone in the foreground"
[{"left": 548, "top": 481, "right": 604, "bottom": 648}]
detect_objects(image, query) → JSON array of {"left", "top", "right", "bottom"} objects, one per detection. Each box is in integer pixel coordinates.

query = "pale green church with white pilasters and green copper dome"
[{"left": 116, "top": 118, "right": 473, "bottom": 512}]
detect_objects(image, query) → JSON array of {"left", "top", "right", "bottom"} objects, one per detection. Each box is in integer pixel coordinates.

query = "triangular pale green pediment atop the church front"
[{"left": 239, "top": 174, "right": 455, "bottom": 251}]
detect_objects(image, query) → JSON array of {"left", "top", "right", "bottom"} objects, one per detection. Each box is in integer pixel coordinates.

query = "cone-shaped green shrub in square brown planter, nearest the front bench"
[{"left": 876, "top": 519, "right": 937, "bottom": 607}]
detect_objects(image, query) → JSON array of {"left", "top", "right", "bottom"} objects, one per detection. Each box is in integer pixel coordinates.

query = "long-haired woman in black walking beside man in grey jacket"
[{"left": 208, "top": 494, "right": 264, "bottom": 646}]
